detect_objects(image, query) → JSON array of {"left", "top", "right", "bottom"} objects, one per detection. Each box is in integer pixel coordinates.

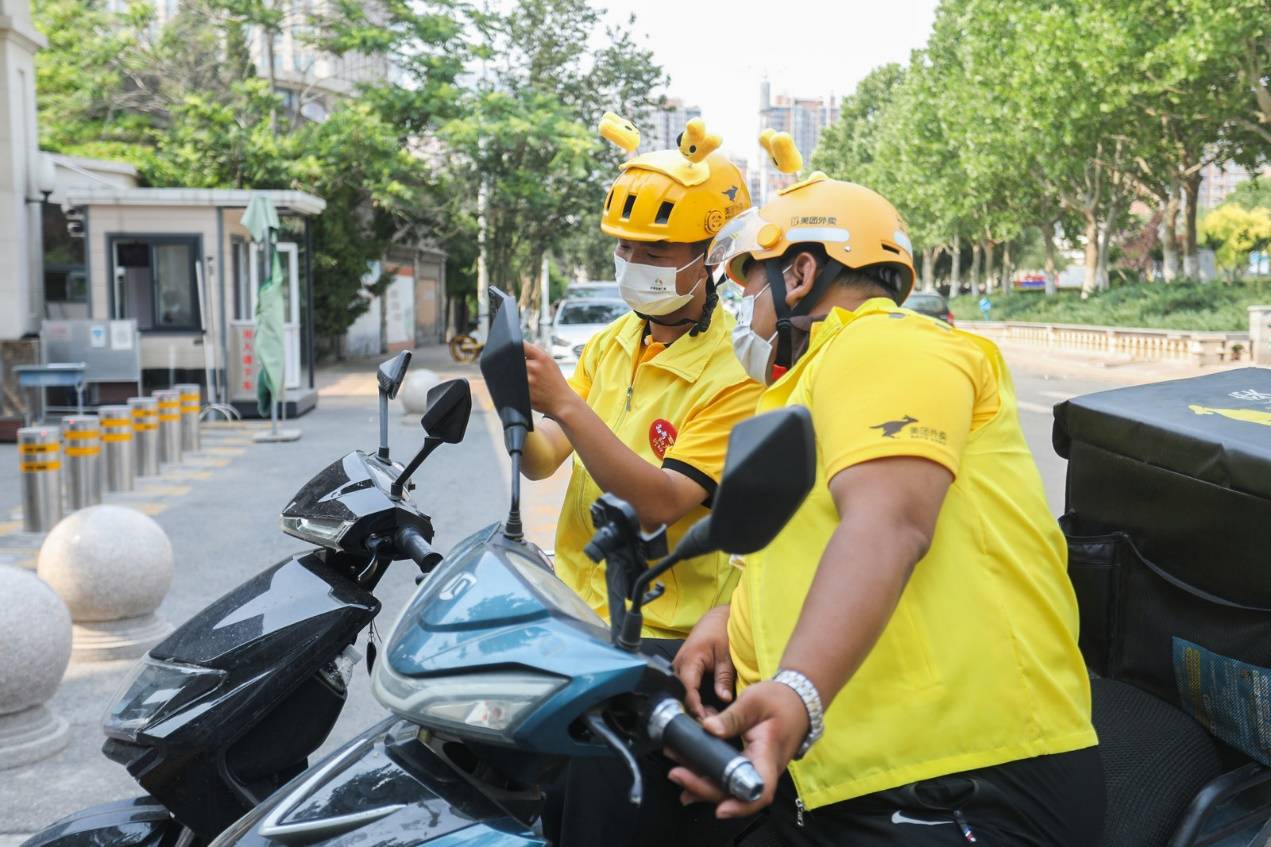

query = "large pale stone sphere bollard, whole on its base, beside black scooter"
[{"left": 36, "top": 505, "right": 172, "bottom": 660}]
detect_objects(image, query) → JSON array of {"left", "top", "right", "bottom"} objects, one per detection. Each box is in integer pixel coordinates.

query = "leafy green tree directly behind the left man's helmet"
[{"left": 440, "top": 0, "right": 665, "bottom": 315}]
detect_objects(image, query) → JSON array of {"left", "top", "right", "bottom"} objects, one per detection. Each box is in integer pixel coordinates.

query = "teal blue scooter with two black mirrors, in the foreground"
[{"left": 203, "top": 290, "right": 815, "bottom": 847}]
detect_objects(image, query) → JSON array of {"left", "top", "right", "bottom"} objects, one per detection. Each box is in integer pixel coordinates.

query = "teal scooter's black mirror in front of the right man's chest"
[{"left": 707, "top": 406, "right": 816, "bottom": 554}]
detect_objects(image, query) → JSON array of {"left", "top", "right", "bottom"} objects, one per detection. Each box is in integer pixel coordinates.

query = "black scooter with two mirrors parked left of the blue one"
[{"left": 23, "top": 352, "right": 472, "bottom": 847}]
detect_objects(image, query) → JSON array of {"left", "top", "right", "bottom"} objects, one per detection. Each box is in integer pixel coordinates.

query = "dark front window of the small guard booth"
[{"left": 111, "top": 235, "right": 200, "bottom": 331}]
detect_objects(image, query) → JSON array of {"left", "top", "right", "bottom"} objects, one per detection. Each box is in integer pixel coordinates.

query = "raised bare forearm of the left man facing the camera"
[{"left": 554, "top": 398, "right": 681, "bottom": 527}]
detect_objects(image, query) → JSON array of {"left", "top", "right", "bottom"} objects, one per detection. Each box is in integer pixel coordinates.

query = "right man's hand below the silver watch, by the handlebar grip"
[{"left": 669, "top": 681, "right": 808, "bottom": 818}]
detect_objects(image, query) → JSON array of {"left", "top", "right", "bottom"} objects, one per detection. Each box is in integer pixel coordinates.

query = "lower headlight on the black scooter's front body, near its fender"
[{"left": 102, "top": 656, "right": 225, "bottom": 741}]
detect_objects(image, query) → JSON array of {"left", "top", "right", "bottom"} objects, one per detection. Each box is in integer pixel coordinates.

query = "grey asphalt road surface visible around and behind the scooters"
[{"left": 0, "top": 351, "right": 1143, "bottom": 847}]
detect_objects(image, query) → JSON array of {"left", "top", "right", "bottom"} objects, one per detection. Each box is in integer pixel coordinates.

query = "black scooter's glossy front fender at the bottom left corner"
[{"left": 22, "top": 797, "right": 182, "bottom": 847}]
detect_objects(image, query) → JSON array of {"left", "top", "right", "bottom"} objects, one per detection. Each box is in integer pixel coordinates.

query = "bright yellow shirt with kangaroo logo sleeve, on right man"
[{"left": 728, "top": 299, "right": 1097, "bottom": 809}]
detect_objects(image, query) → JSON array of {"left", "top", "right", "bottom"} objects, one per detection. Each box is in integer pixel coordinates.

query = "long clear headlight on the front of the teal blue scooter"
[{"left": 372, "top": 660, "right": 567, "bottom": 736}]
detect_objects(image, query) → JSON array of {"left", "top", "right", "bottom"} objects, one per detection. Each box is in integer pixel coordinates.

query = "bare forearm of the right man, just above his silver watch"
[{"left": 782, "top": 515, "right": 925, "bottom": 707}]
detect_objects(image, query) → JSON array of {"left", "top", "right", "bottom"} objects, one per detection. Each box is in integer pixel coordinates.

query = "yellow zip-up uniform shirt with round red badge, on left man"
[{"left": 555, "top": 300, "right": 763, "bottom": 638}]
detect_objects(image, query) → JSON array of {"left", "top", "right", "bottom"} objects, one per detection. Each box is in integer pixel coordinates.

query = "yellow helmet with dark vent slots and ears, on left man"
[{"left": 600, "top": 114, "right": 750, "bottom": 244}]
